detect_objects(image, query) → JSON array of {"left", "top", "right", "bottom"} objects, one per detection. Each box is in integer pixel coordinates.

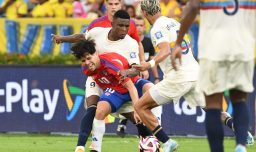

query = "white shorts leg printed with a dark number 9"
[{"left": 85, "top": 77, "right": 103, "bottom": 98}]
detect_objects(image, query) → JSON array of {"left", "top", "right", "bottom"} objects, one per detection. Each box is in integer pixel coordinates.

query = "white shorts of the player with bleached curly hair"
[{"left": 149, "top": 78, "right": 205, "bottom": 107}]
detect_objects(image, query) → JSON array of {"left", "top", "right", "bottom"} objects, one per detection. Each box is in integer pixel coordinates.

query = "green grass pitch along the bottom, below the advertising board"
[{"left": 0, "top": 134, "right": 256, "bottom": 152}]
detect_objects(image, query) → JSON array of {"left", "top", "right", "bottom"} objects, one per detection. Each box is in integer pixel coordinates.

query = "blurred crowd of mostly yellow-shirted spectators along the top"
[{"left": 0, "top": 0, "right": 187, "bottom": 20}]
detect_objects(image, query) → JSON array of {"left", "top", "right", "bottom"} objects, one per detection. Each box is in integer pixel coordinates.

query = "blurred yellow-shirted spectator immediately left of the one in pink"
[{"left": 52, "top": 0, "right": 73, "bottom": 18}]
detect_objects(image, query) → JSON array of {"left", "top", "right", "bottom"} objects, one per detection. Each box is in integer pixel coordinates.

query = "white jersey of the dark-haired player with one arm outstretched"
[{"left": 85, "top": 27, "right": 140, "bottom": 64}]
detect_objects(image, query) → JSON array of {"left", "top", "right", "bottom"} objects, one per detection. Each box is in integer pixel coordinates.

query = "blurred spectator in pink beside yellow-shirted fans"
[{"left": 73, "top": 0, "right": 87, "bottom": 18}]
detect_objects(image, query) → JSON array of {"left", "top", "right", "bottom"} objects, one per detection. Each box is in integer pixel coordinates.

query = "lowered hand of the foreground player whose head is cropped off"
[{"left": 171, "top": 45, "right": 182, "bottom": 71}]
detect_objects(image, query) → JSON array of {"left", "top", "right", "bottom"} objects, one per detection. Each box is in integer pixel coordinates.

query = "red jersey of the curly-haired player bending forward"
[{"left": 83, "top": 52, "right": 139, "bottom": 94}]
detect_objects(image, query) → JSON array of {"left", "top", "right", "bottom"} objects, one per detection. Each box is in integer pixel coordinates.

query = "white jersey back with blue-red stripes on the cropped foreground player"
[{"left": 199, "top": 0, "right": 256, "bottom": 61}]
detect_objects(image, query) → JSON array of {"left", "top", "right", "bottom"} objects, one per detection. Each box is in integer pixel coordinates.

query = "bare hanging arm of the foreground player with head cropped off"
[{"left": 171, "top": 0, "right": 200, "bottom": 70}]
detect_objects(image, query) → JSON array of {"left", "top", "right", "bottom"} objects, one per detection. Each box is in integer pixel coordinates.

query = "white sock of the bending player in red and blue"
[{"left": 91, "top": 118, "right": 105, "bottom": 152}]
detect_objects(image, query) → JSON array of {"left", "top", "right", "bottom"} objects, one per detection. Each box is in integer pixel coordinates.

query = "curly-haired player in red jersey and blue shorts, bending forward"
[{"left": 71, "top": 39, "right": 153, "bottom": 151}]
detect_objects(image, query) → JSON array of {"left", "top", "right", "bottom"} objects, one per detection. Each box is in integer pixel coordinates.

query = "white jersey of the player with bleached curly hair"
[{"left": 150, "top": 16, "right": 199, "bottom": 83}]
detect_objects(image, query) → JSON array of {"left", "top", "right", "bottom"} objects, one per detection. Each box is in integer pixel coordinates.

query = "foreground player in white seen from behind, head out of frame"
[{"left": 172, "top": 0, "right": 256, "bottom": 152}]
